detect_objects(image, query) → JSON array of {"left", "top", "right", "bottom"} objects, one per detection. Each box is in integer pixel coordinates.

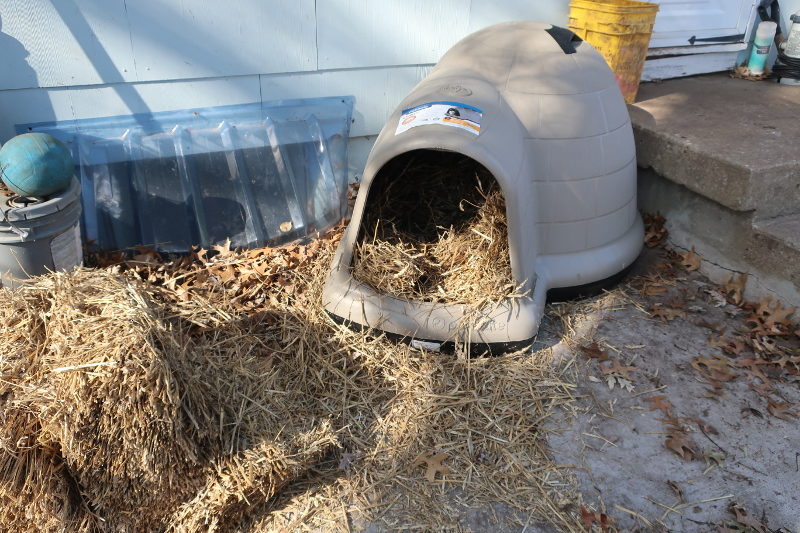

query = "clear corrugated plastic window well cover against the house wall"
[{"left": 18, "top": 97, "right": 353, "bottom": 252}]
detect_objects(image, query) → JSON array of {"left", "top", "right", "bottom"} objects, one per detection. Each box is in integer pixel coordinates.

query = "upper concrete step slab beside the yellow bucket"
[{"left": 629, "top": 74, "right": 800, "bottom": 218}]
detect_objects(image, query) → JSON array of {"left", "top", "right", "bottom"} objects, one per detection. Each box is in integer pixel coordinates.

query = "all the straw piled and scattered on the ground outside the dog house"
[{"left": 0, "top": 223, "right": 580, "bottom": 532}]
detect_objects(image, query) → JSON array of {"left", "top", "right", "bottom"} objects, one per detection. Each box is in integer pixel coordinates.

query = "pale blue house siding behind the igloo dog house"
[{"left": 0, "top": 0, "right": 568, "bottom": 179}]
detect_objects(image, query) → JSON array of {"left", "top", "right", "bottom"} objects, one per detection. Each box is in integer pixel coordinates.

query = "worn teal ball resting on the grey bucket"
[{"left": 0, "top": 133, "right": 75, "bottom": 196}]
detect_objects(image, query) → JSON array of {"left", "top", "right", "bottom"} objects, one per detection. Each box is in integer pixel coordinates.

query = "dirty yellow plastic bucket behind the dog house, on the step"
[{"left": 569, "top": 0, "right": 658, "bottom": 104}]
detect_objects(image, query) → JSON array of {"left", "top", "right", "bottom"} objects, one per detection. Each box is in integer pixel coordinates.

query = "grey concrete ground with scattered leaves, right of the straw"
[{"left": 549, "top": 243, "right": 800, "bottom": 532}]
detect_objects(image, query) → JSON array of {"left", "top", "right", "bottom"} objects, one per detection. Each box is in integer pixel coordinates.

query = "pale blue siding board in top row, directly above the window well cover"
[{"left": 123, "top": 0, "right": 317, "bottom": 81}]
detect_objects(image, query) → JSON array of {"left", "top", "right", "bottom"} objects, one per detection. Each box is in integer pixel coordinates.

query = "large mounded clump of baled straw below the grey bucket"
[{"left": 0, "top": 271, "right": 212, "bottom": 523}]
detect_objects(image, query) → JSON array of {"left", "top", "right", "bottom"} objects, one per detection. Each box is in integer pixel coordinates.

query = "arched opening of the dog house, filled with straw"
[{"left": 352, "top": 150, "right": 516, "bottom": 309}]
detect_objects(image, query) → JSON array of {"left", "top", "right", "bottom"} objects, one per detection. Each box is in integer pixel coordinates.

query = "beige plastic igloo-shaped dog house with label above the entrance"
[{"left": 323, "top": 22, "right": 643, "bottom": 352}]
